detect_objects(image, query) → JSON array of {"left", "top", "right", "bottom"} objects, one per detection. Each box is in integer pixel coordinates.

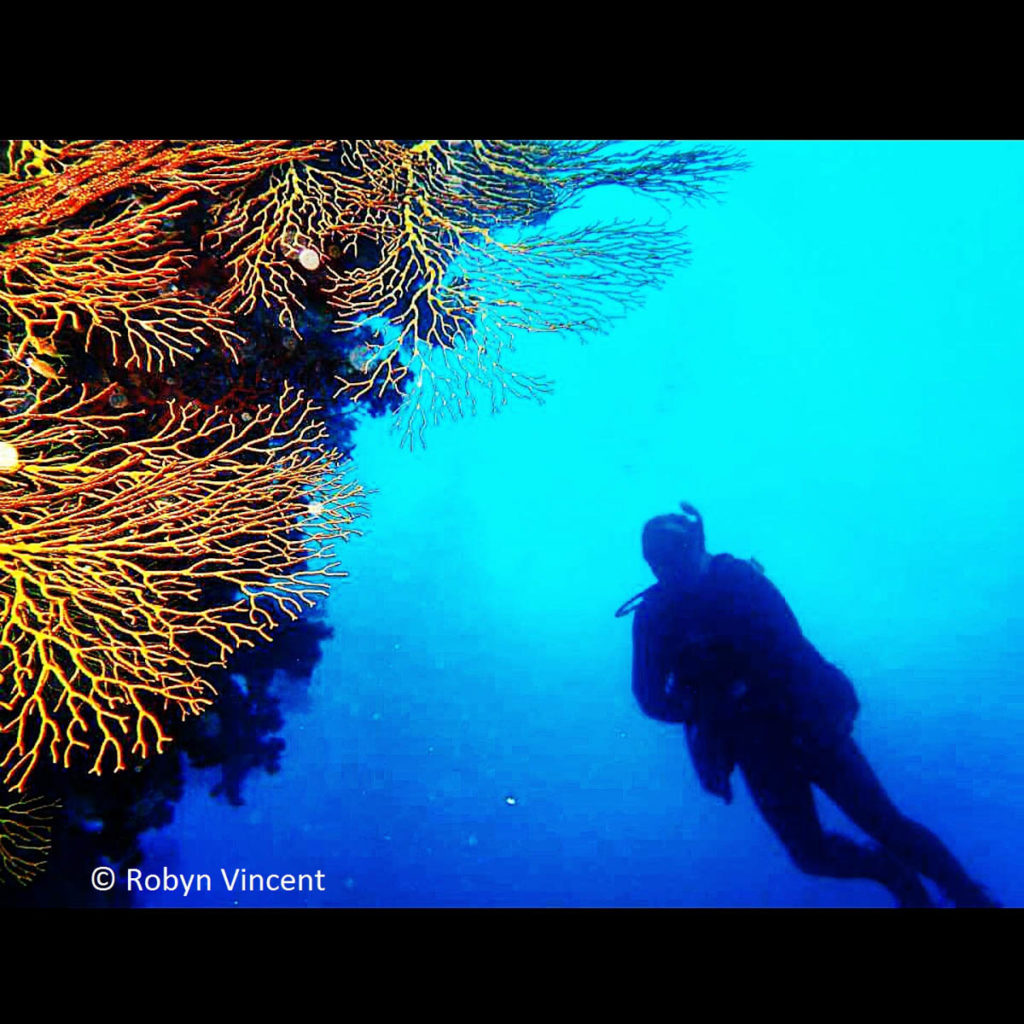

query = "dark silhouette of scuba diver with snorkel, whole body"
[{"left": 615, "top": 503, "right": 999, "bottom": 907}]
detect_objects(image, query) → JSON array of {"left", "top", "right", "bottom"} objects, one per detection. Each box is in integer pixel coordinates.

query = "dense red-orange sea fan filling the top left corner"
[{"left": 0, "top": 139, "right": 323, "bottom": 374}]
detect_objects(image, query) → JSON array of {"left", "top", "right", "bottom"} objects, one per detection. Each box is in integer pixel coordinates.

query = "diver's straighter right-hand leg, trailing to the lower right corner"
[{"left": 808, "top": 737, "right": 998, "bottom": 906}]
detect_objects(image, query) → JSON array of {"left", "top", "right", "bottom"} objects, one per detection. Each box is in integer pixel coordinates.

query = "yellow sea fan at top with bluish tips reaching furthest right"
[{"left": 333, "top": 139, "right": 740, "bottom": 440}]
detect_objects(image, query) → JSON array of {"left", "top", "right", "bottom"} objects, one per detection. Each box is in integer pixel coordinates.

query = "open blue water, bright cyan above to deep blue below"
[{"left": 139, "top": 142, "right": 1024, "bottom": 907}]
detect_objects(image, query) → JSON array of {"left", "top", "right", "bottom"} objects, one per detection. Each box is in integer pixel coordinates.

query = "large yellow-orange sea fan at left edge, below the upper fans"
[{"left": 0, "top": 367, "right": 361, "bottom": 790}]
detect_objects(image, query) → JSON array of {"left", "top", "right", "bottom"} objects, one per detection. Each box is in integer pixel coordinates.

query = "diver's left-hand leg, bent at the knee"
[{"left": 738, "top": 741, "right": 932, "bottom": 906}]
